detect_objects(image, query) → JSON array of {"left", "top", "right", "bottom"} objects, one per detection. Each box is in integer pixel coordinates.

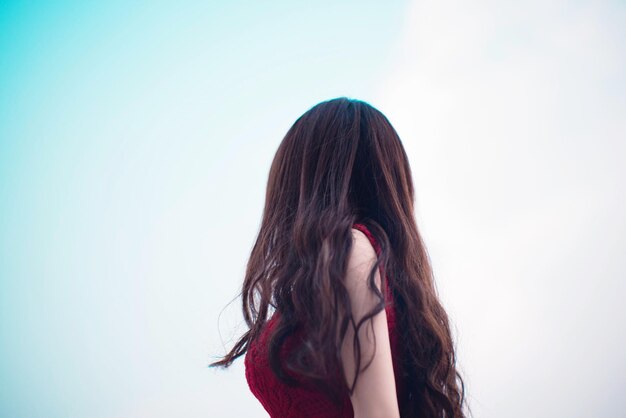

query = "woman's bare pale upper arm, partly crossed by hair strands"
[{"left": 341, "top": 229, "right": 400, "bottom": 418}]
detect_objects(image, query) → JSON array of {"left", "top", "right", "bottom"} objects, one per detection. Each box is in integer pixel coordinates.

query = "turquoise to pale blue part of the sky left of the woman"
[{"left": 0, "top": 1, "right": 406, "bottom": 418}]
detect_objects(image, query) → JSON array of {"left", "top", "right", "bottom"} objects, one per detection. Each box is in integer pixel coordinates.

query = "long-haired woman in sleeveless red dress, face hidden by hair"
[{"left": 211, "top": 97, "right": 465, "bottom": 418}]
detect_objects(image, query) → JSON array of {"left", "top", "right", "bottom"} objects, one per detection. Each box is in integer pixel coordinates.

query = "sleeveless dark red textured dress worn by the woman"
[{"left": 244, "top": 223, "right": 403, "bottom": 418}]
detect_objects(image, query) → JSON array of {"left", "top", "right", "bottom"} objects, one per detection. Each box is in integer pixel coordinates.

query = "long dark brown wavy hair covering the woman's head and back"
[{"left": 209, "top": 97, "right": 466, "bottom": 418}]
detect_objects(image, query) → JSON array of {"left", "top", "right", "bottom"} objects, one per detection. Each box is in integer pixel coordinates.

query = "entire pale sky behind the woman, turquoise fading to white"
[{"left": 0, "top": 0, "right": 626, "bottom": 418}]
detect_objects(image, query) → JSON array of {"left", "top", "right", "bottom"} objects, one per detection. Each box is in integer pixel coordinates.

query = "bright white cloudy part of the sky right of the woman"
[{"left": 377, "top": 1, "right": 626, "bottom": 418}]
